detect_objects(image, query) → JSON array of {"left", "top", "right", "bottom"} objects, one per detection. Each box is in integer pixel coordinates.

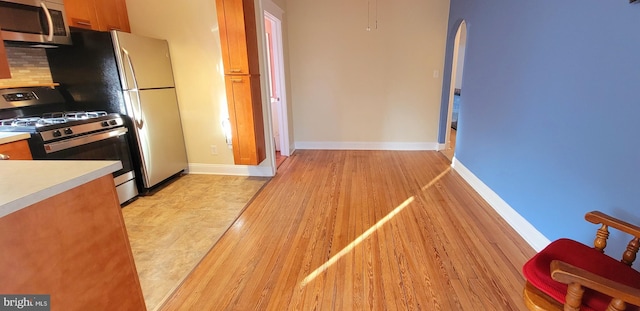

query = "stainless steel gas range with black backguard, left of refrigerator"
[{"left": 0, "top": 88, "right": 138, "bottom": 203}]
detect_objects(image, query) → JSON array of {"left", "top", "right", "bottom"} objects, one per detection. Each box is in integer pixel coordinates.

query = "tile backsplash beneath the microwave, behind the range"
[{"left": 0, "top": 46, "right": 53, "bottom": 87}]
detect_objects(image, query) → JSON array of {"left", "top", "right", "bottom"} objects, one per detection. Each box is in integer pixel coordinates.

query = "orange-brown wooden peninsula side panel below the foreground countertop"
[{"left": 0, "top": 174, "right": 146, "bottom": 310}]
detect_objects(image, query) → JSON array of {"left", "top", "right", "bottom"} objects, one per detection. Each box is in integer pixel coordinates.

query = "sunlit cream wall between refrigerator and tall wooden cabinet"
[{"left": 127, "top": 0, "right": 233, "bottom": 165}]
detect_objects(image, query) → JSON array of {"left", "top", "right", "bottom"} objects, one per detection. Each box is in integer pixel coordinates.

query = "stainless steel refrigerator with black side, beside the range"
[{"left": 47, "top": 29, "right": 187, "bottom": 193}]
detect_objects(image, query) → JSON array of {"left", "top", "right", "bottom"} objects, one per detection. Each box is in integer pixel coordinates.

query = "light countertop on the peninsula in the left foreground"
[{"left": 0, "top": 160, "right": 122, "bottom": 217}]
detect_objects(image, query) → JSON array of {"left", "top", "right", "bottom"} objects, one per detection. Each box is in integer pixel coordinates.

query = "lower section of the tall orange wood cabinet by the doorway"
[{"left": 225, "top": 76, "right": 266, "bottom": 165}]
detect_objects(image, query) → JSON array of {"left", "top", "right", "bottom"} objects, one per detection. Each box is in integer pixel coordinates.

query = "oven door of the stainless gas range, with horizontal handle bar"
[{"left": 44, "top": 127, "right": 133, "bottom": 177}]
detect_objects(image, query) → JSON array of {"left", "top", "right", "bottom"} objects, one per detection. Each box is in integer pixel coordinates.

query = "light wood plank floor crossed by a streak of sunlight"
[{"left": 162, "top": 150, "right": 534, "bottom": 310}]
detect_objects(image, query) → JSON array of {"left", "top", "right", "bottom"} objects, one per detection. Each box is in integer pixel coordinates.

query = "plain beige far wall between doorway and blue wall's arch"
[{"left": 286, "top": 0, "right": 449, "bottom": 148}]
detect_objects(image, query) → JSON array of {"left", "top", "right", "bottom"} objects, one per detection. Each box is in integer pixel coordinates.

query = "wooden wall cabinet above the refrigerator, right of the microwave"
[{"left": 64, "top": 0, "right": 131, "bottom": 32}]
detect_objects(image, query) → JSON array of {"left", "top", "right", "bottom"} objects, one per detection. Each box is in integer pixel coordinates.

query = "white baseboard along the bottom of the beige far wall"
[{"left": 295, "top": 141, "right": 439, "bottom": 150}]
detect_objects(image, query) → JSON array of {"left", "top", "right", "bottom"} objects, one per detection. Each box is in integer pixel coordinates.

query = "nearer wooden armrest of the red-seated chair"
[{"left": 551, "top": 260, "right": 640, "bottom": 306}]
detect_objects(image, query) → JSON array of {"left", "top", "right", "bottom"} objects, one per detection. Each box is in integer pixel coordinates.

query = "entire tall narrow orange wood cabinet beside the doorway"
[{"left": 216, "top": 0, "right": 266, "bottom": 165}]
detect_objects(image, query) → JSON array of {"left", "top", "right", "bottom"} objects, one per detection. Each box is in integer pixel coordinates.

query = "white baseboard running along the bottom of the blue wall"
[{"left": 451, "top": 158, "right": 551, "bottom": 252}]
